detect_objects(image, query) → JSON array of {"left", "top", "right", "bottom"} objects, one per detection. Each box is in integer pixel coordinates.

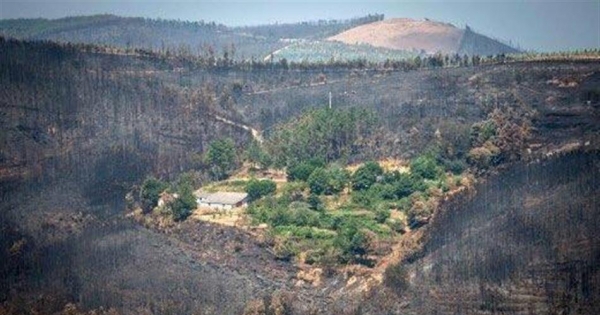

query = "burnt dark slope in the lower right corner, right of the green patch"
[{"left": 364, "top": 151, "right": 600, "bottom": 315}]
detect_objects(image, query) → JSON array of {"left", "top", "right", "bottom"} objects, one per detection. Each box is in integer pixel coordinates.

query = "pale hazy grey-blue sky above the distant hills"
[{"left": 0, "top": 0, "right": 600, "bottom": 51}]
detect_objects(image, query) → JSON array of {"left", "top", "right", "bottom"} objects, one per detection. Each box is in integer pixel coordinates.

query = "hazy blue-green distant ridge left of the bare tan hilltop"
[{"left": 0, "top": 14, "right": 383, "bottom": 59}]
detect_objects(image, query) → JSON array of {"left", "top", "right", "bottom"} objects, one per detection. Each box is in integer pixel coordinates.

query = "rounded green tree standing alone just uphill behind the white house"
[{"left": 204, "top": 138, "right": 236, "bottom": 180}]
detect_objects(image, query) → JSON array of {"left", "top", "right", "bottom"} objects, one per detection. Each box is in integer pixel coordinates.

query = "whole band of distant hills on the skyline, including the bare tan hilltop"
[{"left": 0, "top": 14, "right": 518, "bottom": 62}]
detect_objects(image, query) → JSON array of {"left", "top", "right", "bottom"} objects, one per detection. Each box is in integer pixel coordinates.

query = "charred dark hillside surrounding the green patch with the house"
[{"left": 0, "top": 38, "right": 600, "bottom": 315}]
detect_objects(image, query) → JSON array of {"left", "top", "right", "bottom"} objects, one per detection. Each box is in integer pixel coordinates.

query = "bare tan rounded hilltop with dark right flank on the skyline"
[{"left": 327, "top": 18, "right": 519, "bottom": 55}]
